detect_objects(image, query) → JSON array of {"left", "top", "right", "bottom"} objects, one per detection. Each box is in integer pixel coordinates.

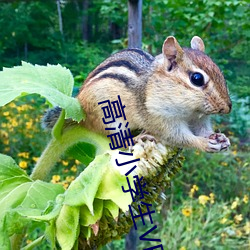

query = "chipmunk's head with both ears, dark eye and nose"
[{"left": 157, "top": 36, "right": 232, "bottom": 114}]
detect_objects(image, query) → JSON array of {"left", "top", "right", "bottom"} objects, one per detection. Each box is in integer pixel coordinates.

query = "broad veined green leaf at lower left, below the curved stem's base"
[{"left": 0, "top": 181, "right": 64, "bottom": 236}]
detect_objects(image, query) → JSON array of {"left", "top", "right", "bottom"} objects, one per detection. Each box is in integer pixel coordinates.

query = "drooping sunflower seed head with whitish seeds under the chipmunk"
[{"left": 79, "top": 141, "right": 183, "bottom": 250}]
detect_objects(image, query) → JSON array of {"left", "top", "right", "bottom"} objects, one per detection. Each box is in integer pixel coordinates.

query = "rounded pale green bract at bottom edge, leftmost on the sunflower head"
[{"left": 56, "top": 205, "right": 80, "bottom": 250}]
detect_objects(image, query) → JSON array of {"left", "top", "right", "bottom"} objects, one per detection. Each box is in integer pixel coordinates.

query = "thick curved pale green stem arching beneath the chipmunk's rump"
[{"left": 30, "top": 125, "right": 109, "bottom": 180}]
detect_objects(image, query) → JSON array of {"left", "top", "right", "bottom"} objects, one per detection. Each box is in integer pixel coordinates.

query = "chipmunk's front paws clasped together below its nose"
[{"left": 207, "top": 133, "right": 230, "bottom": 153}]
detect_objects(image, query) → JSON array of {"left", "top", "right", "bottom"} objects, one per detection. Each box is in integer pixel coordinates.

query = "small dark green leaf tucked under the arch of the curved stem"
[{"left": 66, "top": 142, "right": 96, "bottom": 165}]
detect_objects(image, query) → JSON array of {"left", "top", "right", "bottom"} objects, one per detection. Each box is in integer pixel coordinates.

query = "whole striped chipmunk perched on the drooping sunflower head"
[{"left": 43, "top": 36, "right": 232, "bottom": 152}]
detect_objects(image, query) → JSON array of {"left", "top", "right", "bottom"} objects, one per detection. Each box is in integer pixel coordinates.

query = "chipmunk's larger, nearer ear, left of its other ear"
[{"left": 162, "top": 36, "right": 184, "bottom": 62}]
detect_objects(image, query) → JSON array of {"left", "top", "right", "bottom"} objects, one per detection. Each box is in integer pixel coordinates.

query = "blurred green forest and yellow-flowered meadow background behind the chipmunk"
[{"left": 0, "top": 0, "right": 250, "bottom": 250}]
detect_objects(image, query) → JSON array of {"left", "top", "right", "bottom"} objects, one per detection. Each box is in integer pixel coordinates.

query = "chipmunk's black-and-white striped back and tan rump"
[{"left": 77, "top": 49, "right": 155, "bottom": 133}]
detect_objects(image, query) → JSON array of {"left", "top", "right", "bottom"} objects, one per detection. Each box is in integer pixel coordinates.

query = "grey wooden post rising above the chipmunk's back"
[{"left": 128, "top": 0, "right": 142, "bottom": 48}]
